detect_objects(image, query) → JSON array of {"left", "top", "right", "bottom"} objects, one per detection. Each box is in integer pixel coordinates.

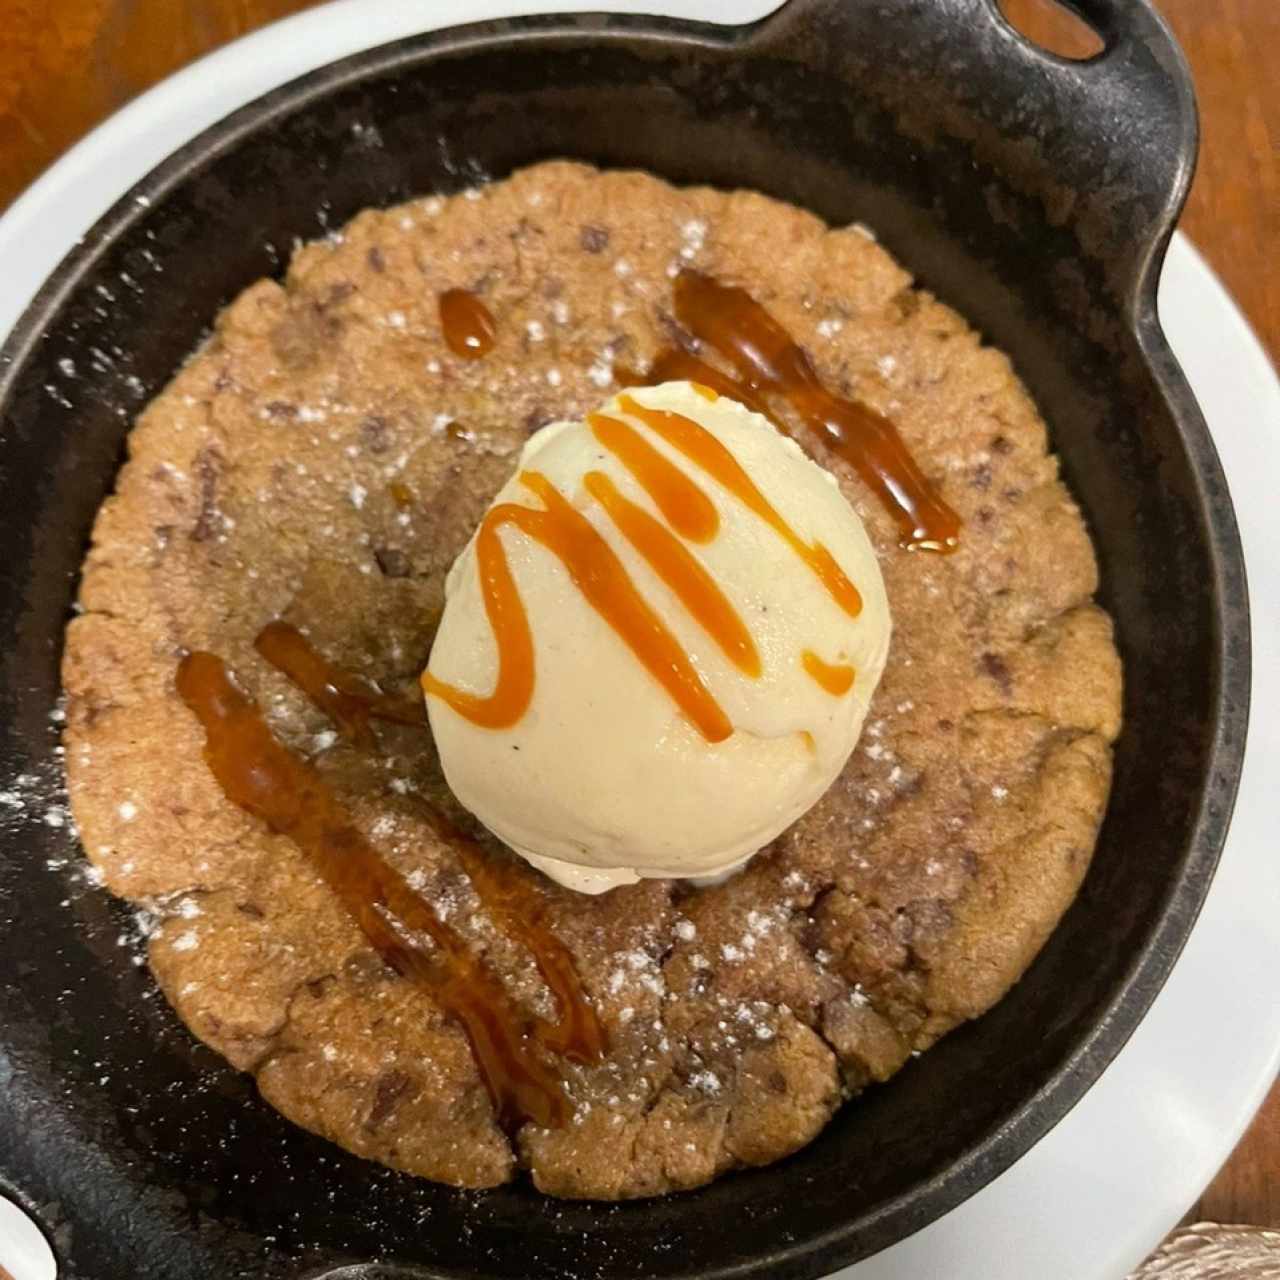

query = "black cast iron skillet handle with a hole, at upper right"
[{"left": 744, "top": 0, "right": 1199, "bottom": 289}]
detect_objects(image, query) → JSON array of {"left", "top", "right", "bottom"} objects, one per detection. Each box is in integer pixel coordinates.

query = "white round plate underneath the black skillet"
[{"left": 0, "top": 0, "right": 1280, "bottom": 1280}]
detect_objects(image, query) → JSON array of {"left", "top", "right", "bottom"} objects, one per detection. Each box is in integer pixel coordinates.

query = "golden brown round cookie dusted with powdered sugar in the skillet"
[{"left": 64, "top": 163, "right": 1120, "bottom": 1198}]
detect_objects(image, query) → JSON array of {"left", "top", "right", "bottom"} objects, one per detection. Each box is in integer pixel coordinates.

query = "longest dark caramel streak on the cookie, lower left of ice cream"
[{"left": 177, "top": 652, "right": 588, "bottom": 1128}]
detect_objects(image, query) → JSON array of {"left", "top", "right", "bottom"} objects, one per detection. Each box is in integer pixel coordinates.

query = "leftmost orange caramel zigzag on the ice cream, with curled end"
[{"left": 422, "top": 471, "right": 733, "bottom": 742}]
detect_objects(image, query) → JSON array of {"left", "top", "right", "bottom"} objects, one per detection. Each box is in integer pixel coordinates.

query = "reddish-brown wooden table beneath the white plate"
[{"left": 0, "top": 0, "right": 1280, "bottom": 1249}]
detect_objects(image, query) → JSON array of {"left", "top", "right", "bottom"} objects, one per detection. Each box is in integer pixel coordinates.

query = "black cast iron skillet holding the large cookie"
[{"left": 0, "top": 0, "right": 1248, "bottom": 1280}]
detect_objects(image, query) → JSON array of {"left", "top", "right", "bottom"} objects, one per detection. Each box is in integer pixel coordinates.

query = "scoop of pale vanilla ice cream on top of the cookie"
[{"left": 426, "top": 383, "right": 890, "bottom": 893}]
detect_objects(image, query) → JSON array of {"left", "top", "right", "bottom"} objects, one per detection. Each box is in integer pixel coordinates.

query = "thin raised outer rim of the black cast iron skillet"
[{"left": 0, "top": 0, "right": 1249, "bottom": 1280}]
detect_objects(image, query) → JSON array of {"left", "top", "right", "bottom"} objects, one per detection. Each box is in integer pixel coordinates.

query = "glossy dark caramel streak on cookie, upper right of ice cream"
[{"left": 646, "top": 269, "right": 960, "bottom": 553}]
